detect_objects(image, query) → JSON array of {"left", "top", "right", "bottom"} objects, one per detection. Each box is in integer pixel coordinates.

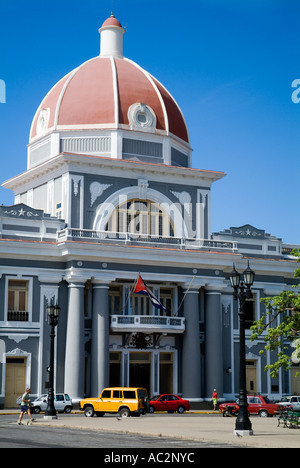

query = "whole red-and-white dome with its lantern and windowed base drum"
[{"left": 28, "top": 14, "right": 191, "bottom": 168}]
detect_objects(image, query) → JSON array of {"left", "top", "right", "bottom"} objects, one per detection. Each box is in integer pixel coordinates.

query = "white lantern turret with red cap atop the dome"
[{"left": 99, "top": 12, "right": 125, "bottom": 58}]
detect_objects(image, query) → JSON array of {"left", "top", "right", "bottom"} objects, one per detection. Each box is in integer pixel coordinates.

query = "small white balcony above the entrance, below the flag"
[{"left": 110, "top": 315, "right": 185, "bottom": 334}]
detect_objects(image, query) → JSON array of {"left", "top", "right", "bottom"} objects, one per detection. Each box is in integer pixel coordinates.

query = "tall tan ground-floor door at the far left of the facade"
[{"left": 4, "top": 357, "right": 26, "bottom": 408}]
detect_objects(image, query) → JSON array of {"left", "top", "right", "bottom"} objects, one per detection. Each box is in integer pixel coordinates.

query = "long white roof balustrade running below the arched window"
[{"left": 57, "top": 227, "right": 237, "bottom": 252}]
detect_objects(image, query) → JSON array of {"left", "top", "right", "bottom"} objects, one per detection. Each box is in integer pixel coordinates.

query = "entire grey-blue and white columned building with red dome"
[{"left": 0, "top": 15, "right": 300, "bottom": 407}]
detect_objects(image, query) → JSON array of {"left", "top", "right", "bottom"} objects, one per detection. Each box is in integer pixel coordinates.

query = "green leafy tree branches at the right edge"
[{"left": 251, "top": 249, "right": 300, "bottom": 377}]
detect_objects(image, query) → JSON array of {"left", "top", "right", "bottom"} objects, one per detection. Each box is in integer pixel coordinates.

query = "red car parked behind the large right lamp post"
[{"left": 219, "top": 395, "right": 280, "bottom": 418}]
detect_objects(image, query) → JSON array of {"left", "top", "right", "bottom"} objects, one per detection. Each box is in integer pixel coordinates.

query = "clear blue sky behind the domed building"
[{"left": 0, "top": 0, "right": 300, "bottom": 244}]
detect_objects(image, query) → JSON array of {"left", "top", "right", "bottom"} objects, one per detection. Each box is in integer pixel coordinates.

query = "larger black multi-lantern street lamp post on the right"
[{"left": 229, "top": 262, "right": 255, "bottom": 436}]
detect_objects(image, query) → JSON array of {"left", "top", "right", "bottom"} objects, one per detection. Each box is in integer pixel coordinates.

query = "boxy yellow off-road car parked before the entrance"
[{"left": 80, "top": 387, "right": 149, "bottom": 418}]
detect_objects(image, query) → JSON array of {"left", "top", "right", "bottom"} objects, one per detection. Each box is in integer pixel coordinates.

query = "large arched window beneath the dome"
[{"left": 106, "top": 199, "right": 174, "bottom": 237}]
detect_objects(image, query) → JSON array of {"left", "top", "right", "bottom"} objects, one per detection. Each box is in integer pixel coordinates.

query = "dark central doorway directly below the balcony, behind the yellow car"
[{"left": 129, "top": 351, "right": 151, "bottom": 395}]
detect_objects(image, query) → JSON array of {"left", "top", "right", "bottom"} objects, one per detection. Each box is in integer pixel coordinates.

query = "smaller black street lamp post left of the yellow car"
[{"left": 44, "top": 303, "right": 60, "bottom": 419}]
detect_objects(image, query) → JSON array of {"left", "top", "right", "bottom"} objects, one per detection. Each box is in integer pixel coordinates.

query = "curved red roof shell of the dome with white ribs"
[{"left": 30, "top": 54, "right": 189, "bottom": 142}]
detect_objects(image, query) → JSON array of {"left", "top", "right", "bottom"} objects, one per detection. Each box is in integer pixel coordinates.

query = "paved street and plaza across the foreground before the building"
[{"left": 0, "top": 413, "right": 300, "bottom": 453}]
